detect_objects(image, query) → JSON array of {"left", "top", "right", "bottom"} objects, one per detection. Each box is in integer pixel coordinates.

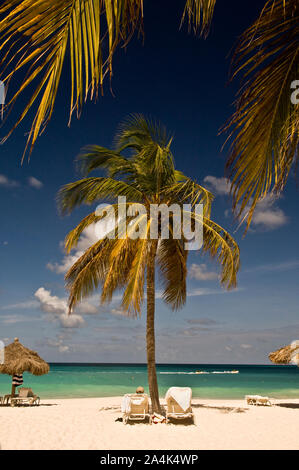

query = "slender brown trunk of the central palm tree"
[{"left": 146, "top": 243, "right": 161, "bottom": 413}]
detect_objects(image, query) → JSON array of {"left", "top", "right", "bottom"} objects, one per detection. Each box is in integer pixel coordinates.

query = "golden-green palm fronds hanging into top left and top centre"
[{"left": 0, "top": 0, "right": 215, "bottom": 158}]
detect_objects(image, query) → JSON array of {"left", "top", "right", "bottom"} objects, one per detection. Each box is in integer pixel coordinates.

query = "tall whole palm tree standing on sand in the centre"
[{"left": 58, "top": 115, "right": 239, "bottom": 412}]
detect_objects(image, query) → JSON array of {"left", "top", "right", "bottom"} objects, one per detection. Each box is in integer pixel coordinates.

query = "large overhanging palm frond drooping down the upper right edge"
[{"left": 225, "top": 0, "right": 299, "bottom": 228}]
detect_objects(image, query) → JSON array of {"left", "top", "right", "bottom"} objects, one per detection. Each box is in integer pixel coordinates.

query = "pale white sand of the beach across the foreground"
[{"left": 0, "top": 397, "right": 299, "bottom": 450}]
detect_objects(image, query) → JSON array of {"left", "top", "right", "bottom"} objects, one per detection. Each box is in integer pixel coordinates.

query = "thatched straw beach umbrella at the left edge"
[{"left": 0, "top": 338, "right": 50, "bottom": 396}]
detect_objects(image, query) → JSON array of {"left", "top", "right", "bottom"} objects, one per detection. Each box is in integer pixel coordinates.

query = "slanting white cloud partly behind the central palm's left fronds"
[{"left": 47, "top": 224, "right": 99, "bottom": 274}]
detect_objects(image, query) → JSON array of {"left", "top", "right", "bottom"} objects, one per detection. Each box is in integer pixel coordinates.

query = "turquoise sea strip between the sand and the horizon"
[{"left": 0, "top": 364, "right": 299, "bottom": 398}]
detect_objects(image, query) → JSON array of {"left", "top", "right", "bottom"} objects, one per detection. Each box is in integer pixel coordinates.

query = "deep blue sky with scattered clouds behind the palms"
[{"left": 0, "top": 0, "right": 299, "bottom": 363}]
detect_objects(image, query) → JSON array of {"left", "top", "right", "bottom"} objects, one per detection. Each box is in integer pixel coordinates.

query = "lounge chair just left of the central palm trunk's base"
[{"left": 121, "top": 393, "right": 152, "bottom": 424}]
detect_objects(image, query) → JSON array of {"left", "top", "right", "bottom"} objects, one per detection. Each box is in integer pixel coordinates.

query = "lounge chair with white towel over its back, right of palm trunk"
[{"left": 165, "top": 387, "right": 195, "bottom": 424}]
